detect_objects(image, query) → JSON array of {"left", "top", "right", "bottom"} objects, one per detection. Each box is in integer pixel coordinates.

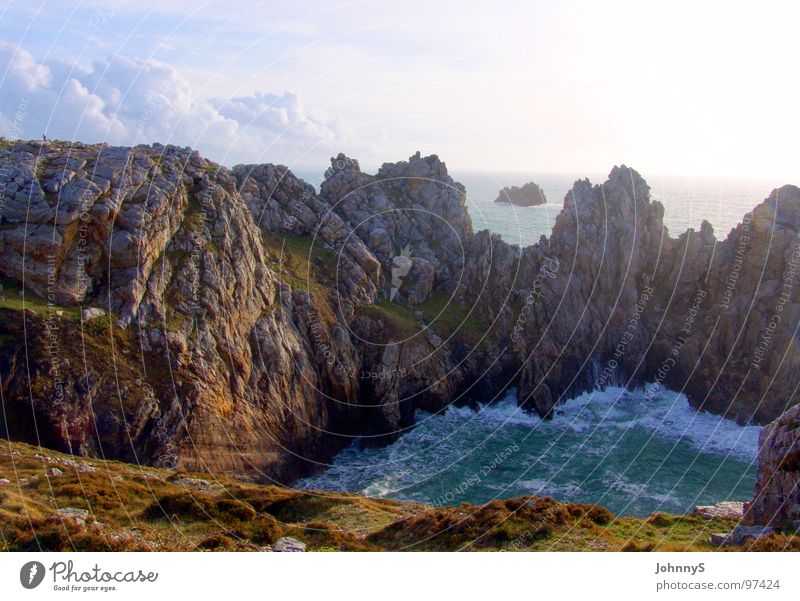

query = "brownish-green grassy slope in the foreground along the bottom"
[{"left": 0, "top": 441, "right": 800, "bottom": 551}]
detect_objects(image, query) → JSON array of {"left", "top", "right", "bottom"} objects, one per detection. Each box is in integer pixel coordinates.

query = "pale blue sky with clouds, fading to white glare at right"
[{"left": 0, "top": 0, "right": 800, "bottom": 178}]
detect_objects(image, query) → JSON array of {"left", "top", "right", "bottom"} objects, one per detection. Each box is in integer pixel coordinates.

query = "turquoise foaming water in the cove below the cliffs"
[{"left": 297, "top": 388, "right": 759, "bottom": 515}]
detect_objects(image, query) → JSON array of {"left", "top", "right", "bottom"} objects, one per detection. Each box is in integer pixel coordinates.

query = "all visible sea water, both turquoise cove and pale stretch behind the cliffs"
[{"left": 296, "top": 173, "right": 784, "bottom": 516}]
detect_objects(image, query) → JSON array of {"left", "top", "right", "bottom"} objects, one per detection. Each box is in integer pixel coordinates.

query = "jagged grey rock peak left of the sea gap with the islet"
[{"left": 320, "top": 152, "right": 472, "bottom": 304}]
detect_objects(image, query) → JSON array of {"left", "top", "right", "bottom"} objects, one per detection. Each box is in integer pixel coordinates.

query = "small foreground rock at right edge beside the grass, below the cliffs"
[{"left": 745, "top": 406, "right": 800, "bottom": 529}]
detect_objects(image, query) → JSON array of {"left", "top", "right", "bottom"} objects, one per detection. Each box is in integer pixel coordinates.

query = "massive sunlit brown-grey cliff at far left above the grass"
[{"left": 0, "top": 143, "right": 348, "bottom": 477}]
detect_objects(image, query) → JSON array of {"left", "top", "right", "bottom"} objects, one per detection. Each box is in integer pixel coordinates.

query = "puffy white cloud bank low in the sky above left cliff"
[{"left": 0, "top": 44, "right": 349, "bottom": 165}]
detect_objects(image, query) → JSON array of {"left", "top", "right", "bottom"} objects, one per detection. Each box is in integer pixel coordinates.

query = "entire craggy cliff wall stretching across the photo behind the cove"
[{"left": 0, "top": 142, "right": 800, "bottom": 481}]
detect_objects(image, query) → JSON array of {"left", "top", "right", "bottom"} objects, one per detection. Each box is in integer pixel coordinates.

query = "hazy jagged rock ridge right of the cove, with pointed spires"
[{"left": 446, "top": 166, "right": 800, "bottom": 423}]
